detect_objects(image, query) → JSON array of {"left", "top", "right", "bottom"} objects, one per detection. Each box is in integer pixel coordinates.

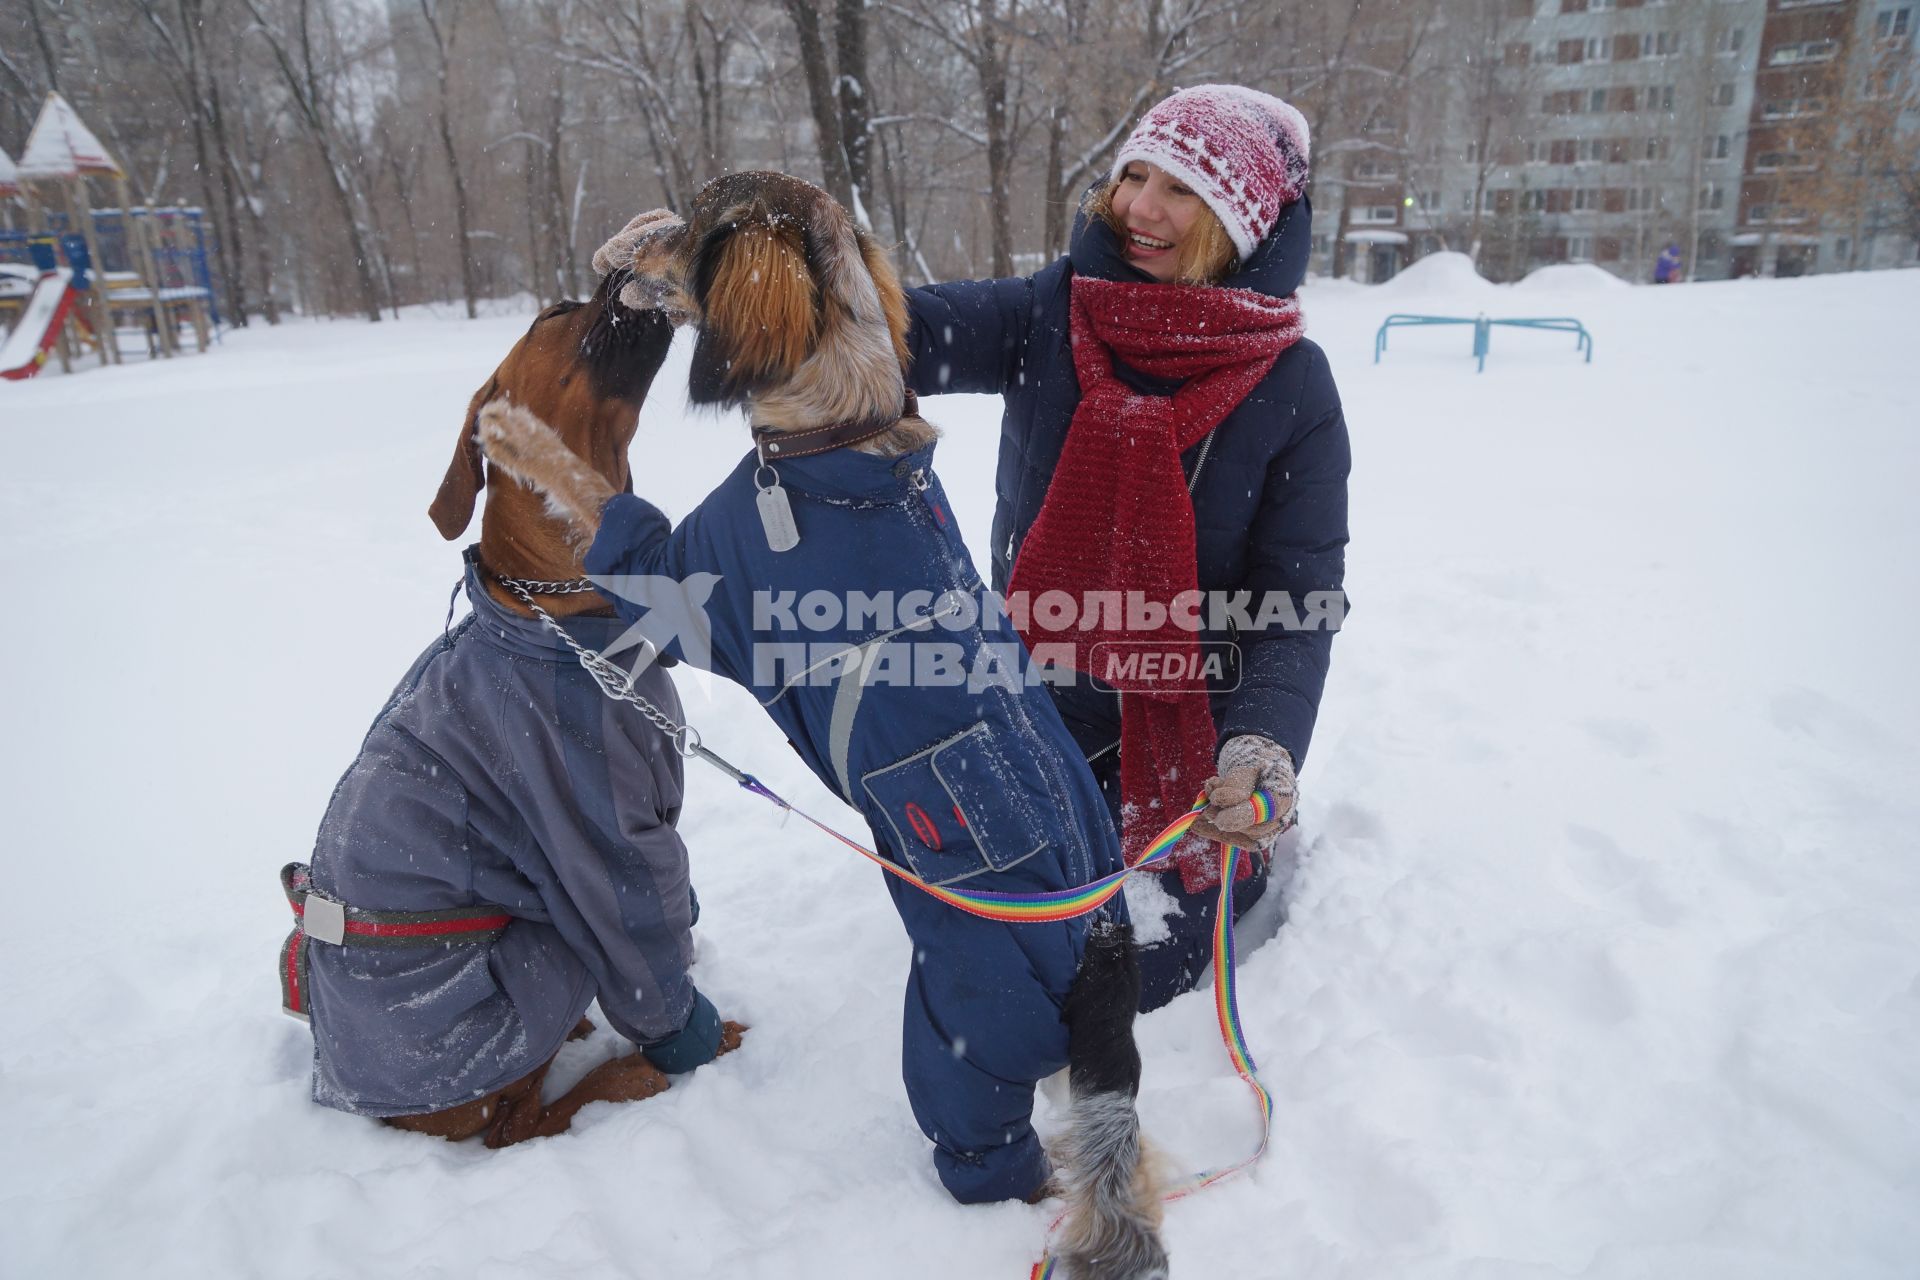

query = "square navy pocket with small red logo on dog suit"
[{"left": 860, "top": 720, "right": 1046, "bottom": 885}]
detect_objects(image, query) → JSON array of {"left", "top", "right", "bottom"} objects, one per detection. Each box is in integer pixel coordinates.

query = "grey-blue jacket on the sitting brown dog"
[{"left": 284, "top": 553, "right": 718, "bottom": 1115}]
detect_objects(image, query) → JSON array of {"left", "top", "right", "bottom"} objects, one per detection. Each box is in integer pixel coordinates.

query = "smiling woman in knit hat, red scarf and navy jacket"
[{"left": 908, "top": 84, "right": 1348, "bottom": 1009}]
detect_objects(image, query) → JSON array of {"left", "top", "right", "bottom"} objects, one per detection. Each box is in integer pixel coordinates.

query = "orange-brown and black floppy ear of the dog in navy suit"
[{"left": 687, "top": 201, "right": 820, "bottom": 405}]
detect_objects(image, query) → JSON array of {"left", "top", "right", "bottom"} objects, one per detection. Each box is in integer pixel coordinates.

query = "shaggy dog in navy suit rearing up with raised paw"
[{"left": 478, "top": 173, "right": 1167, "bottom": 1280}]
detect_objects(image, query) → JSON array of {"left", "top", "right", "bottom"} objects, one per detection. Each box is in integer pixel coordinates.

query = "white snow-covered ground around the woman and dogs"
[{"left": 0, "top": 267, "right": 1920, "bottom": 1280}]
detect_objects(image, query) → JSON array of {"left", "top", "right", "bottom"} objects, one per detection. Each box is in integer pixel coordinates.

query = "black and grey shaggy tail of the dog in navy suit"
[{"left": 1060, "top": 919, "right": 1167, "bottom": 1280}]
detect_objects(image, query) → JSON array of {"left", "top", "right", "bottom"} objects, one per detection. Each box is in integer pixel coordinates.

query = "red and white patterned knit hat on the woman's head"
[{"left": 1112, "top": 84, "right": 1308, "bottom": 259}]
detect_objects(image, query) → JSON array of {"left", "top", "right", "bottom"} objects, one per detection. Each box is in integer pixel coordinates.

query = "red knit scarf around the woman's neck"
[{"left": 1008, "top": 276, "right": 1302, "bottom": 892}]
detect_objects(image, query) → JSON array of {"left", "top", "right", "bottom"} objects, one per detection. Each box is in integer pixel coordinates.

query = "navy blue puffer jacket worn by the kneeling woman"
[{"left": 906, "top": 200, "right": 1348, "bottom": 764}]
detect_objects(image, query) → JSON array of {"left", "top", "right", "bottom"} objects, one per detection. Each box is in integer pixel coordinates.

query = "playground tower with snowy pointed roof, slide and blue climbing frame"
[{"left": 0, "top": 94, "right": 219, "bottom": 378}]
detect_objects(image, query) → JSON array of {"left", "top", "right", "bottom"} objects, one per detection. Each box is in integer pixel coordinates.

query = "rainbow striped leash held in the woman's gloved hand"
[{"left": 721, "top": 767, "right": 1273, "bottom": 1280}]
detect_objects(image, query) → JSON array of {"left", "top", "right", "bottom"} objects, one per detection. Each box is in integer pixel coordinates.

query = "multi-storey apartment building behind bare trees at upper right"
[{"left": 1315, "top": 0, "right": 1920, "bottom": 280}]
